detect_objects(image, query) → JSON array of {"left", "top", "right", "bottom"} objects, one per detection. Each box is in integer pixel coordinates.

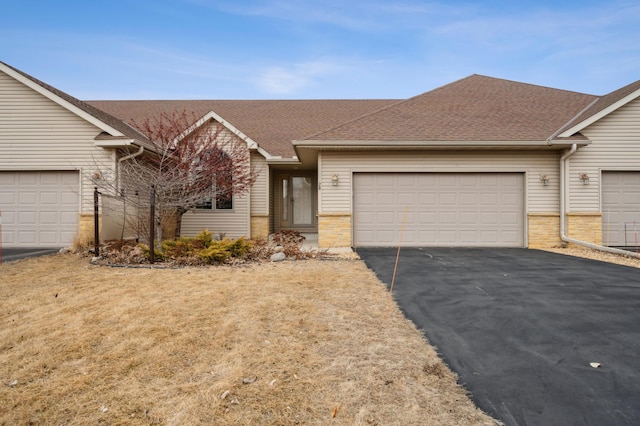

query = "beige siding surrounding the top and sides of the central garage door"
[{"left": 318, "top": 151, "right": 559, "bottom": 213}]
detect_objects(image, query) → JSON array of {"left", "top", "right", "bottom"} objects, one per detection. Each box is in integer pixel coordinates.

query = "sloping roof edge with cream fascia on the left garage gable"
[{"left": 0, "top": 61, "right": 153, "bottom": 148}]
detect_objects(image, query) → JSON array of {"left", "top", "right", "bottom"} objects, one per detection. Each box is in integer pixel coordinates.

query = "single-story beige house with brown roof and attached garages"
[{"left": 0, "top": 63, "right": 640, "bottom": 248}]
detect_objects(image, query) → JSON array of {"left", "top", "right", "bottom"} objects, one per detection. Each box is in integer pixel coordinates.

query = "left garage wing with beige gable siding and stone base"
[{"left": 0, "top": 62, "right": 151, "bottom": 247}]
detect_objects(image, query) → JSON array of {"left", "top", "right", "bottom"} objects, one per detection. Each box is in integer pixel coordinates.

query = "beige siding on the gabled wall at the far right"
[{"left": 568, "top": 100, "right": 640, "bottom": 212}]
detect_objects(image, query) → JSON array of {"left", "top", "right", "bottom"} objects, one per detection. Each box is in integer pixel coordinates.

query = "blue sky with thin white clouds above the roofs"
[{"left": 0, "top": 0, "right": 640, "bottom": 99}]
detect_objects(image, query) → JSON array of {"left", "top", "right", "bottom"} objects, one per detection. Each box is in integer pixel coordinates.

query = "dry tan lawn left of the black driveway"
[{"left": 0, "top": 254, "right": 494, "bottom": 425}]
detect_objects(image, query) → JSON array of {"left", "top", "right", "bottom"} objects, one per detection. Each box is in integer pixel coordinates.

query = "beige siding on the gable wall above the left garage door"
[{"left": 0, "top": 72, "right": 115, "bottom": 216}]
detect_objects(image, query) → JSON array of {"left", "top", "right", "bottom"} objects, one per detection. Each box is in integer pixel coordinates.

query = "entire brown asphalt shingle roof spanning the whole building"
[{"left": 11, "top": 58, "right": 640, "bottom": 158}]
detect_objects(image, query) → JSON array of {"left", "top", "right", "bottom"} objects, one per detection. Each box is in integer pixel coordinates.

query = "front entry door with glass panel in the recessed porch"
[{"left": 278, "top": 174, "right": 316, "bottom": 231}]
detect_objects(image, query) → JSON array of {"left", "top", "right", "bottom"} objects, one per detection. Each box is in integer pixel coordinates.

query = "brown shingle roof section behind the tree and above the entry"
[{"left": 87, "top": 99, "right": 398, "bottom": 158}]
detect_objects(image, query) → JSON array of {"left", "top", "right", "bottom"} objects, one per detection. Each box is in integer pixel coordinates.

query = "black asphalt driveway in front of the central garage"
[{"left": 358, "top": 248, "right": 640, "bottom": 426}]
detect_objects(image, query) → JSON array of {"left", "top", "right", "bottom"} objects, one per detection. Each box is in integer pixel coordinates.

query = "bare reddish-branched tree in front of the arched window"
[{"left": 117, "top": 111, "right": 256, "bottom": 241}]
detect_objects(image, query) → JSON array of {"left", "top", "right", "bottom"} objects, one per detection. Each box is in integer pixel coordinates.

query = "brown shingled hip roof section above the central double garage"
[{"left": 305, "top": 74, "right": 597, "bottom": 142}]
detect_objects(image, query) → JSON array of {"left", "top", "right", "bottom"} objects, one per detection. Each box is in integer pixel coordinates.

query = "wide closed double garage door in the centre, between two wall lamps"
[{"left": 354, "top": 173, "right": 524, "bottom": 247}]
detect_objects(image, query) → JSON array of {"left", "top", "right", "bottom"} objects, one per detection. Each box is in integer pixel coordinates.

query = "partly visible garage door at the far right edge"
[{"left": 602, "top": 172, "right": 640, "bottom": 247}]
